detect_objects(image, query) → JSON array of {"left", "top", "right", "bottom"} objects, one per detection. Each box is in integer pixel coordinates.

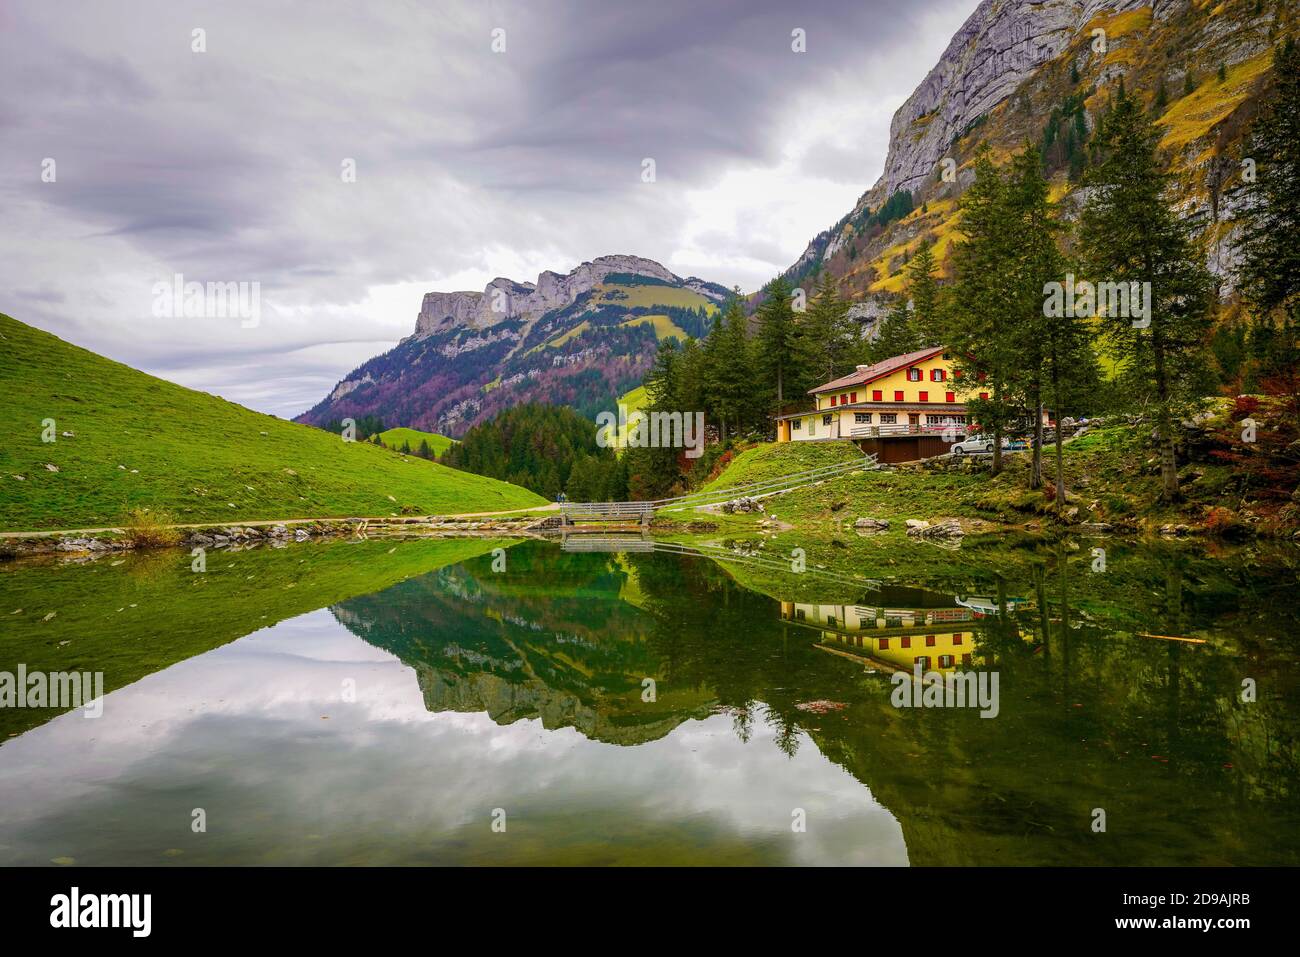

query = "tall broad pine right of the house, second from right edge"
[{"left": 1080, "top": 87, "right": 1213, "bottom": 501}]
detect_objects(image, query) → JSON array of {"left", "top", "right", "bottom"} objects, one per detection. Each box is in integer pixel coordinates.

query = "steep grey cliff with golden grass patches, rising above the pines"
[{"left": 787, "top": 0, "right": 1294, "bottom": 310}]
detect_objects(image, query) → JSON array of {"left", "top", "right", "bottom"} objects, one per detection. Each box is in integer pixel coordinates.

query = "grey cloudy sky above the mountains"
[{"left": 0, "top": 0, "right": 976, "bottom": 416}]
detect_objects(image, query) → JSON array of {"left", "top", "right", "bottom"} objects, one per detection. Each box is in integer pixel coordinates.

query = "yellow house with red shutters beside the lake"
[{"left": 776, "top": 346, "right": 979, "bottom": 449}]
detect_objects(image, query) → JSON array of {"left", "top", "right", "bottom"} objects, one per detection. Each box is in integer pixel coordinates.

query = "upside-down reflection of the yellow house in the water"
[{"left": 781, "top": 589, "right": 1028, "bottom": 671}]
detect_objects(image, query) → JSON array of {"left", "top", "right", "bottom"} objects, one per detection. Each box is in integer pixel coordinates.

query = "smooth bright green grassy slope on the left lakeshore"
[{"left": 0, "top": 315, "right": 543, "bottom": 531}]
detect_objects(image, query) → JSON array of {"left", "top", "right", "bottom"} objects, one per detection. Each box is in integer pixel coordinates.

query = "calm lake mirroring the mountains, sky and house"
[{"left": 0, "top": 536, "right": 1300, "bottom": 866}]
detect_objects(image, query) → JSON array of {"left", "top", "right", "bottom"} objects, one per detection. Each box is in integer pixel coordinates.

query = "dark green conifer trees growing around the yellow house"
[{"left": 627, "top": 39, "right": 1300, "bottom": 501}]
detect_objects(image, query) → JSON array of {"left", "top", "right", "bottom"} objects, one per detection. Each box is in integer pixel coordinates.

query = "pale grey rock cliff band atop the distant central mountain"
[{"left": 415, "top": 256, "right": 683, "bottom": 337}]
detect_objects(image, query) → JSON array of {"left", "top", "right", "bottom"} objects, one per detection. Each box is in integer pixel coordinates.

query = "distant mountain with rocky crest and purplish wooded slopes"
[{"left": 296, "top": 254, "right": 731, "bottom": 437}]
